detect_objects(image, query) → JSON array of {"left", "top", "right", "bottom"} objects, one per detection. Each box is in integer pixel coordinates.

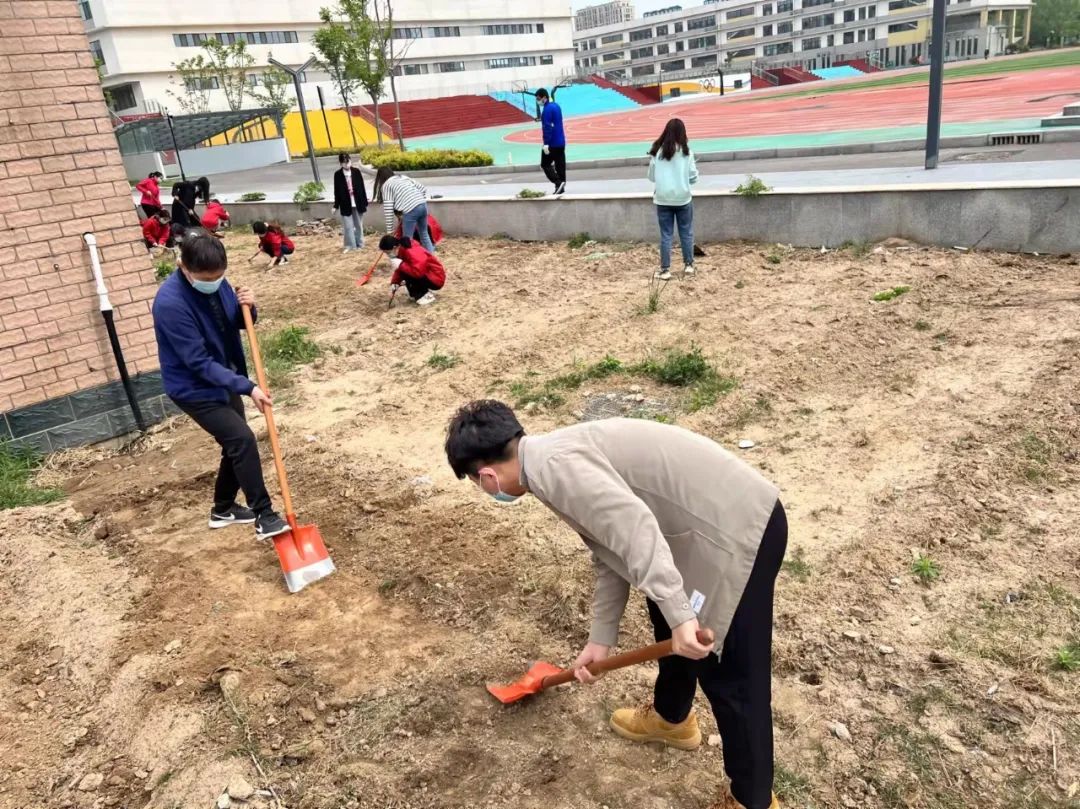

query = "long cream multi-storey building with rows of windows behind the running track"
[{"left": 573, "top": 0, "right": 1031, "bottom": 84}]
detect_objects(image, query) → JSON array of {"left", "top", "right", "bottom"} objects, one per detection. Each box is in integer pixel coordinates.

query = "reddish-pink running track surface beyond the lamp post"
[{"left": 507, "top": 67, "right": 1080, "bottom": 144}]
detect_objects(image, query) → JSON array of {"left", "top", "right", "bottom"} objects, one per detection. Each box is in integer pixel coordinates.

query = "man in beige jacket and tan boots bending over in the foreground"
[{"left": 445, "top": 400, "right": 787, "bottom": 809}]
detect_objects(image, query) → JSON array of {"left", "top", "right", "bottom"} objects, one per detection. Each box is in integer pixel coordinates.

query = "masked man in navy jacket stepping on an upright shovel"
[{"left": 153, "top": 228, "right": 288, "bottom": 539}]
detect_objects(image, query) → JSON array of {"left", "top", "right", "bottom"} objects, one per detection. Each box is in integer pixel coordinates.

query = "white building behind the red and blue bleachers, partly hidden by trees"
[{"left": 77, "top": 0, "right": 573, "bottom": 114}]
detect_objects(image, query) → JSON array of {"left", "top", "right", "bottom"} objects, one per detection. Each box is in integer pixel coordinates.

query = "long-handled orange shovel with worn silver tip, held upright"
[{"left": 241, "top": 306, "right": 335, "bottom": 593}]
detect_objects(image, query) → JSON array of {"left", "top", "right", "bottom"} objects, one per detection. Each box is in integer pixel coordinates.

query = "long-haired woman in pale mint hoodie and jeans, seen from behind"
[{"left": 649, "top": 118, "right": 698, "bottom": 281}]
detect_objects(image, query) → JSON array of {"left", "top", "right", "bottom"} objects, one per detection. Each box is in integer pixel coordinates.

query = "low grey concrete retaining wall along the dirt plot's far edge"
[{"left": 223, "top": 184, "right": 1080, "bottom": 253}]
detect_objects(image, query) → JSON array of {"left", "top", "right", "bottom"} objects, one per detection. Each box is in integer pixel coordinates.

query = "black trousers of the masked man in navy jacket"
[{"left": 173, "top": 395, "right": 272, "bottom": 514}]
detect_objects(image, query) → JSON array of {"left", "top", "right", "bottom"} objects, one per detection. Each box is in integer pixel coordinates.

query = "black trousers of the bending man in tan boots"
[{"left": 649, "top": 501, "right": 787, "bottom": 809}]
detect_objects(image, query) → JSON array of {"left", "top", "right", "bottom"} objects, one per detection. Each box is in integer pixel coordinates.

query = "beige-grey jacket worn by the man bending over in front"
[{"left": 517, "top": 419, "right": 779, "bottom": 648}]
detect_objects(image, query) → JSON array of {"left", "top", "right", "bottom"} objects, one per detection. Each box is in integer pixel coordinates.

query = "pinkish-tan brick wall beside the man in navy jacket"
[{"left": 0, "top": 0, "right": 158, "bottom": 423}]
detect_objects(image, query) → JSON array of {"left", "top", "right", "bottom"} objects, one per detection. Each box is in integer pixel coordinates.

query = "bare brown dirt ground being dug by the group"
[{"left": 0, "top": 226, "right": 1080, "bottom": 809}]
